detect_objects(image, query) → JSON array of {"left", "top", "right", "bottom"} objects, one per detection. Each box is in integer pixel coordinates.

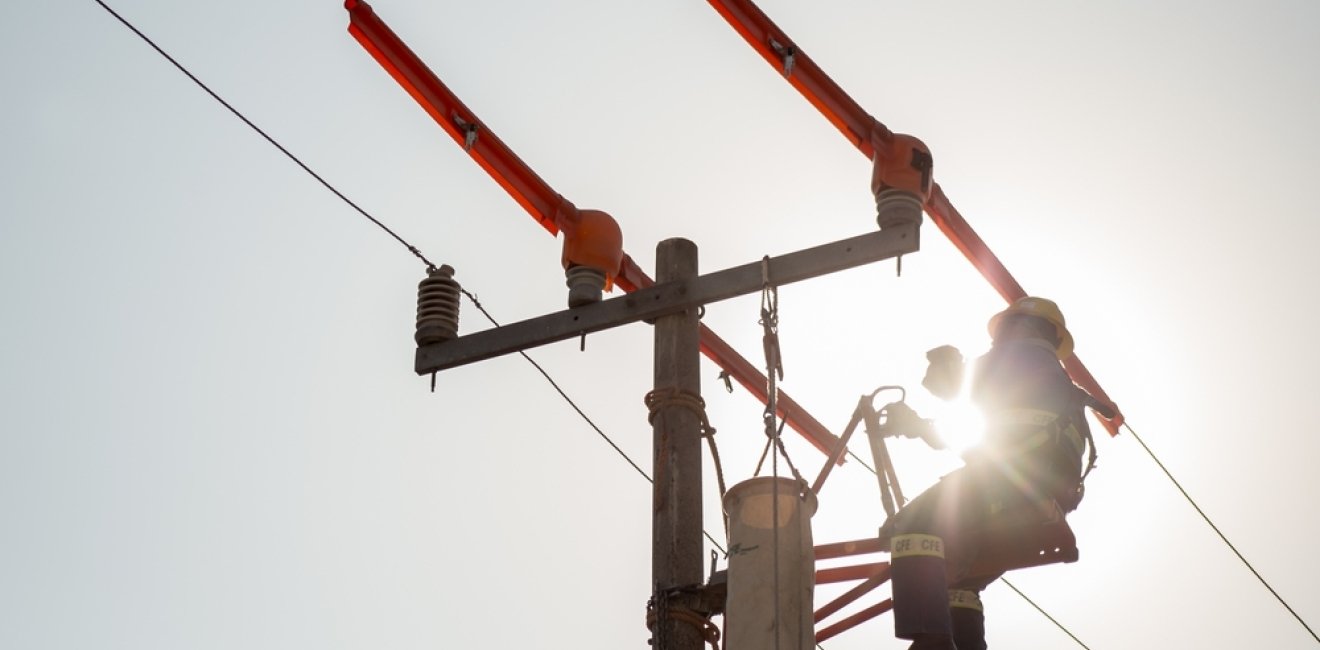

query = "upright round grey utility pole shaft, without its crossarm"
[{"left": 651, "top": 239, "right": 704, "bottom": 650}]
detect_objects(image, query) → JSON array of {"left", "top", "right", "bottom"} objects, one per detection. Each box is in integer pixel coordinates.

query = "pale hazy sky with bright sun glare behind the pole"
[{"left": 0, "top": 0, "right": 1320, "bottom": 650}]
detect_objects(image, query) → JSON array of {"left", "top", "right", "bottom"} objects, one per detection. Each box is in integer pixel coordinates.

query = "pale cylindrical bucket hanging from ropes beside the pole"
[{"left": 725, "top": 477, "right": 816, "bottom": 650}]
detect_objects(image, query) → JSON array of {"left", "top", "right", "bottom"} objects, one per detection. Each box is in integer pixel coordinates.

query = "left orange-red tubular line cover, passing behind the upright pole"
[{"left": 343, "top": 0, "right": 838, "bottom": 454}]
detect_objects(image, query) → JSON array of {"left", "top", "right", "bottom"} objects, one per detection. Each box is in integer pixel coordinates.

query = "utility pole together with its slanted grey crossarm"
[{"left": 413, "top": 221, "right": 920, "bottom": 650}]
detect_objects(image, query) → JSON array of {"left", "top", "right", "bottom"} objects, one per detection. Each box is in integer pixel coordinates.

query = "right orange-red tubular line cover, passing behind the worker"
[{"left": 708, "top": 0, "right": 1123, "bottom": 435}]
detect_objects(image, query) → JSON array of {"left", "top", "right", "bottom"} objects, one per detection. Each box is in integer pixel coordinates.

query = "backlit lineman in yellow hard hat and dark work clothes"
[{"left": 882, "top": 297, "right": 1090, "bottom": 650}]
